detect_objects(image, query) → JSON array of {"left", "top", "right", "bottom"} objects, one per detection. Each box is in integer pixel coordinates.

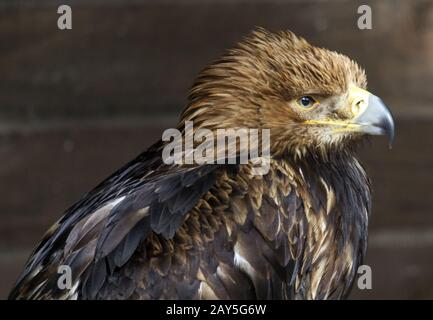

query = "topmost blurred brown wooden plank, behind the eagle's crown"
[{"left": 0, "top": 0, "right": 433, "bottom": 120}]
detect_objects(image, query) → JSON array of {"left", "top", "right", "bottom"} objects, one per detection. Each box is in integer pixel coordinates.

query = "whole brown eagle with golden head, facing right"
[{"left": 9, "top": 28, "right": 394, "bottom": 300}]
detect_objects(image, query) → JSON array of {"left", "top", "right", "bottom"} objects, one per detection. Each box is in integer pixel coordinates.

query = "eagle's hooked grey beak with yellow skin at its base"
[{"left": 349, "top": 87, "right": 394, "bottom": 147}]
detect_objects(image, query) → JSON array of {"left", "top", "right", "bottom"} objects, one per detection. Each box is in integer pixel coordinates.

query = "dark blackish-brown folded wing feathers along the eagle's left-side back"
[{"left": 9, "top": 146, "right": 223, "bottom": 299}]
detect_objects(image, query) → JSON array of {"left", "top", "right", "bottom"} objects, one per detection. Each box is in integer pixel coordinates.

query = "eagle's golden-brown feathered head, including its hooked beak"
[{"left": 181, "top": 28, "right": 394, "bottom": 158}]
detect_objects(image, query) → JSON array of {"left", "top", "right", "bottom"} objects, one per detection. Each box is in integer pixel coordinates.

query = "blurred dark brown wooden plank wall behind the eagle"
[{"left": 0, "top": 0, "right": 433, "bottom": 299}]
